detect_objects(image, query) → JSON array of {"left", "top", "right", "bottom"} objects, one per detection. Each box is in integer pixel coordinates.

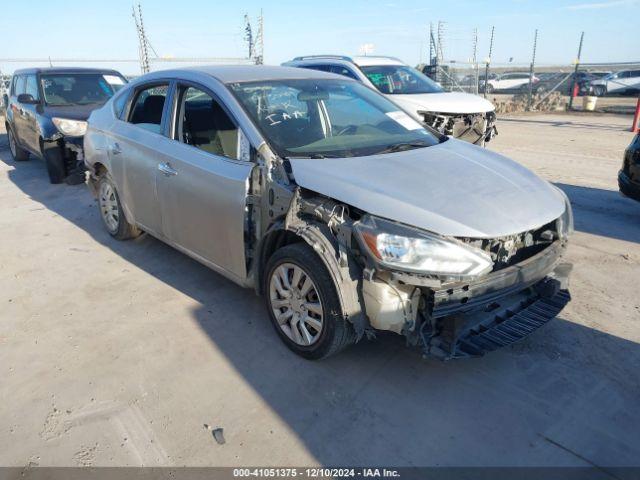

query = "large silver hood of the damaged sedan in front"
[{"left": 289, "top": 139, "right": 565, "bottom": 238}]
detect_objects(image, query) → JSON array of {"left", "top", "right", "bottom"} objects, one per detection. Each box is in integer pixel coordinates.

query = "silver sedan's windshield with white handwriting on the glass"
[{"left": 230, "top": 79, "right": 439, "bottom": 158}]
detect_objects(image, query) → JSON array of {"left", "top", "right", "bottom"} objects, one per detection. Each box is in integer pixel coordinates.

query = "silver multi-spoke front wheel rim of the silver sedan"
[{"left": 269, "top": 263, "right": 324, "bottom": 346}]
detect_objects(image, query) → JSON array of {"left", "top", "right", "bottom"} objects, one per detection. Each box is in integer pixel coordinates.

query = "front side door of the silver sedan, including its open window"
[{"left": 157, "top": 82, "right": 253, "bottom": 280}]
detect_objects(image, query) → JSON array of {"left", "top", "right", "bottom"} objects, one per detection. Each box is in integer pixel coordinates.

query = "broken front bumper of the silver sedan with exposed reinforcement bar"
[{"left": 363, "top": 240, "right": 572, "bottom": 359}]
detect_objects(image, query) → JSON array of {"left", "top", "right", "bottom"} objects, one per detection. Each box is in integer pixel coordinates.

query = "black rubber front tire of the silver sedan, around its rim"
[{"left": 263, "top": 242, "right": 356, "bottom": 360}]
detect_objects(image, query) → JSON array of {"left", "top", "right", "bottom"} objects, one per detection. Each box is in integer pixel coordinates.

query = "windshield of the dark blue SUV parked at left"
[{"left": 40, "top": 73, "right": 124, "bottom": 106}]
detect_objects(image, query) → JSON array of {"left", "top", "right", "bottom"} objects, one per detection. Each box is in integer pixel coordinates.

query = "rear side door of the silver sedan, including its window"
[{"left": 107, "top": 80, "right": 172, "bottom": 236}]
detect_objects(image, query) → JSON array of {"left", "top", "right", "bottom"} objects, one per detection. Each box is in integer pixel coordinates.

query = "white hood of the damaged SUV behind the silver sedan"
[{"left": 386, "top": 92, "right": 495, "bottom": 113}]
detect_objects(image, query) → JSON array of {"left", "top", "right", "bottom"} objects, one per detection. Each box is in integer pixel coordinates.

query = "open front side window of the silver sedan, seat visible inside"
[{"left": 175, "top": 87, "right": 238, "bottom": 159}]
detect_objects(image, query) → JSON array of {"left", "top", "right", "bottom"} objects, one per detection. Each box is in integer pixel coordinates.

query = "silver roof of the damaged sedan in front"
[{"left": 136, "top": 65, "right": 349, "bottom": 83}]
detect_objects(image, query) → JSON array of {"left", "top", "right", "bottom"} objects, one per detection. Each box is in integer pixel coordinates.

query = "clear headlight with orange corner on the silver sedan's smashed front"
[{"left": 355, "top": 215, "right": 493, "bottom": 280}]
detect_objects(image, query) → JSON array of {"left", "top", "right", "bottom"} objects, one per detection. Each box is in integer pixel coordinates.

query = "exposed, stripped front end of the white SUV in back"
[{"left": 418, "top": 111, "right": 498, "bottom": 145}]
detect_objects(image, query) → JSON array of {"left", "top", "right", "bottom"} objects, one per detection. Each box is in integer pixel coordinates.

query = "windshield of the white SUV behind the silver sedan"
[{"left": 360, "top": 65, "right": 443, "bottom": 95}]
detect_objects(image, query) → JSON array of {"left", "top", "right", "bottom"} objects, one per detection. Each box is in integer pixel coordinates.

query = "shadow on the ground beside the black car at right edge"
[{"left": 555, "top": 183, "right": 640, "bottom": 243}]
